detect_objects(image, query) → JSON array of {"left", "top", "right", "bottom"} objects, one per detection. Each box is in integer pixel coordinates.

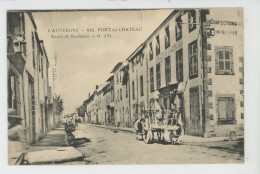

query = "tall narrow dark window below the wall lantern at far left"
[{"left": 8, "top": 71, "right": 19, "bottom": 114}]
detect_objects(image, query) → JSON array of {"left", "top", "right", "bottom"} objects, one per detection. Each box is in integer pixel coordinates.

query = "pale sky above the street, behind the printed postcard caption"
[{"left": 33, "top": 9, "right": 172, "bottom": 114}]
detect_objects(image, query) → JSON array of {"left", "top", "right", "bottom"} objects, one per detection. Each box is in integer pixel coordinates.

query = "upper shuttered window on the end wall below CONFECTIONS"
[{"left": 215, "top": 47, "right": 234, "bottom": 75}]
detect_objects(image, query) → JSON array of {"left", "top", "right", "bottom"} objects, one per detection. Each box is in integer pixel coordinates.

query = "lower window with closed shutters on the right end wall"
[{"left": 217, "top": 96, "right": 235, "bottom": 124}]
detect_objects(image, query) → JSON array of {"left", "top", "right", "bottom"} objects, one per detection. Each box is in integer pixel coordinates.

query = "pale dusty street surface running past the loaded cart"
[{"left": 62, "top": 124, "right": 244, "bottom": 164}]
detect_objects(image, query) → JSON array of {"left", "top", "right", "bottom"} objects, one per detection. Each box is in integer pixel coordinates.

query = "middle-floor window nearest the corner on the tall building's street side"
[{"left": 189, "top": 41, "right": 198, "bottom": 79}]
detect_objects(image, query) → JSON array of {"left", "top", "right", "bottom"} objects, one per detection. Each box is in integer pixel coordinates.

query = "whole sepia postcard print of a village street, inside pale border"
[{"left": 7, "top": 8, "right": 246, "bottom": 166}]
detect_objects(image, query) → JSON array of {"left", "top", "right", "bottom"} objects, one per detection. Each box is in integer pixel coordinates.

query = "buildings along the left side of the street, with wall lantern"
[{"left": 7, "top": 12, "right": 60, "bottom": 144}]
